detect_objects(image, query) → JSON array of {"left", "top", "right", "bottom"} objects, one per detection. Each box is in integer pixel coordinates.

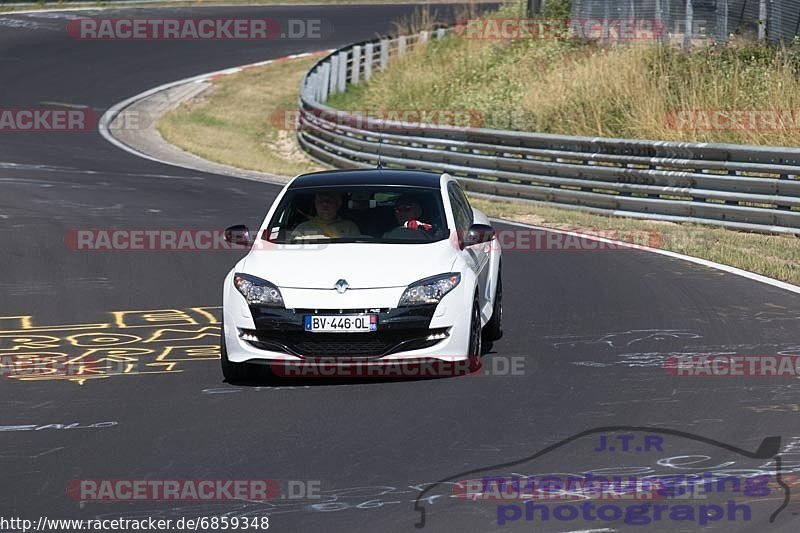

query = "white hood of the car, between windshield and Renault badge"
[{"left": 244, "top": 239, "right": 455, "bottom": 289}]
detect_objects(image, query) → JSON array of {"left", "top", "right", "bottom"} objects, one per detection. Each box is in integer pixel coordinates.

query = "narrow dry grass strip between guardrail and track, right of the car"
[{"left": 470, "top": 197, "right": 800, "bottom": 285}]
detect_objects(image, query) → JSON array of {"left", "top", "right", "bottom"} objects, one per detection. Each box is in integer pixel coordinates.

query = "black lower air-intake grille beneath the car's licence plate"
[{"left": 247, "top": 328, "right": 446, "bottom": 358}]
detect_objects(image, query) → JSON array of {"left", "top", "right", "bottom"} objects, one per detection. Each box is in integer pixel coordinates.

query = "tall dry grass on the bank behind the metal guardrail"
[{"left": 331, "top": 0, "right": 800, "bottom": 146}]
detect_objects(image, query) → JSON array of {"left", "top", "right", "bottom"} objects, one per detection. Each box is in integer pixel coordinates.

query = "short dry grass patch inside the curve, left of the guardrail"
[{"left": 158, "top": 57, "right": 322, "bottom": 175}]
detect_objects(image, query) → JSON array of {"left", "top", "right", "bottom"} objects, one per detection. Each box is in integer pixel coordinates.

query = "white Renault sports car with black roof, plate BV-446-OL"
[{"left": 221, "top": 169, "right": 502, "bottom": 381}]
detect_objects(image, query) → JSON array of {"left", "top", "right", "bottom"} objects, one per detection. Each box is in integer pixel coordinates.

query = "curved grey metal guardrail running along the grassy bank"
[{"left": 297, "top": 29, "right": 800, "bottom": 236}]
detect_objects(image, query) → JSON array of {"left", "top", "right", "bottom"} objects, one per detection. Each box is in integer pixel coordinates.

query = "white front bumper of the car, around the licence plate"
[{"left": 223, "top": 271, "right": 474, "bottom": 366}]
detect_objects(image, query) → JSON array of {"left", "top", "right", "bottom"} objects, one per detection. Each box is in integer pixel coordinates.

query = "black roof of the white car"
[{"left": 289, "top": 169, "right": 441, "bottom": 189}]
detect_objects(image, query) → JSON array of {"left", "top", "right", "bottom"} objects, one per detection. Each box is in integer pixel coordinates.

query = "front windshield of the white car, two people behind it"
[{"left": 261, "top": 186, "right": 449, "bottom": 244}]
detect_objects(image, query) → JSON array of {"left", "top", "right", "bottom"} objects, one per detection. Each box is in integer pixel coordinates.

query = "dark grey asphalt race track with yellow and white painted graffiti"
[{"left": 0, "top": 6, "right": 800, "bottom": 532}]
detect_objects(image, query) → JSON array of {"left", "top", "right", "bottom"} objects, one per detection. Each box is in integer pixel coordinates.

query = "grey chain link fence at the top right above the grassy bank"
[{"left": 571, "top": 0, "right": 800, "bottom": 46}]
